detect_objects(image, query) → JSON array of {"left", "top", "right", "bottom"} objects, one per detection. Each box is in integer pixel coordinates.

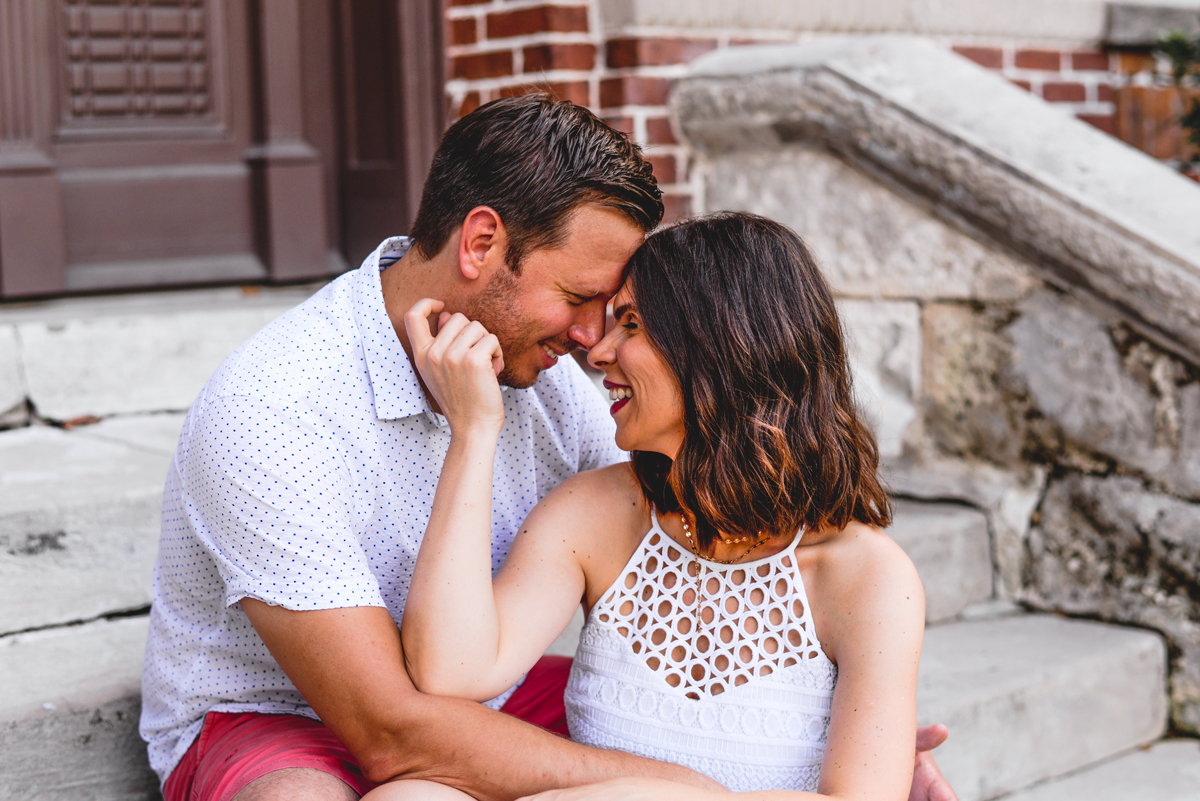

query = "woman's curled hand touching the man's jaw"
[{"left": 404, "top": 297, "right": 504, "bottom": 432}]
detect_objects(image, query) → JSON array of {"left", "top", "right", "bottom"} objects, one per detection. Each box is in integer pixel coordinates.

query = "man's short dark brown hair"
[{"left": 412, "top": 95, "right": 662, "bottom": 273}]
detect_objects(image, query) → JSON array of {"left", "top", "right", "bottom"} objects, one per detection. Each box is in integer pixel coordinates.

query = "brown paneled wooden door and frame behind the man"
[{"left": 0, "top": 0, "right": 443, "bottom": 297}]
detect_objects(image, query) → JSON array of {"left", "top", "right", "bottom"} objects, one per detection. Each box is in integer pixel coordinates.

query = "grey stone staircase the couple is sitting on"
[{"left": 0, "top": 290, "right": 1185, "bottom": 801}]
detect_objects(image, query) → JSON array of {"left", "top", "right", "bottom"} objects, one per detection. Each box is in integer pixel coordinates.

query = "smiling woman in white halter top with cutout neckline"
[{"left": 393, "top": 213, "right": 924, "bottom": 801}]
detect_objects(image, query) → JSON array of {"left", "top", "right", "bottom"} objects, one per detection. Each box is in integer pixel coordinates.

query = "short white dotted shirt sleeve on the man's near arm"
[{"left": 178, "top": 396, "right": 385, "bottom": 610}]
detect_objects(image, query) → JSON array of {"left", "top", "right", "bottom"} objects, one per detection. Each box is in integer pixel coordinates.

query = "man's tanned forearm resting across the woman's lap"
[{"left": 360, "top": 694, "right": 720, "bottom": 801}]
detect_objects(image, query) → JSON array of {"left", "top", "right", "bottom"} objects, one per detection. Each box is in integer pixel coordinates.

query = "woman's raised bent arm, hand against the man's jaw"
[{"left": 401, "top": 301, "right": 595, "bottom": 700}]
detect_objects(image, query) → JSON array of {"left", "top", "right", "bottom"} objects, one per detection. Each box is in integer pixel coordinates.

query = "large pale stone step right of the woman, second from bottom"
[{"left": 918, "top": 615, "right": 1166, "bottom": 801}]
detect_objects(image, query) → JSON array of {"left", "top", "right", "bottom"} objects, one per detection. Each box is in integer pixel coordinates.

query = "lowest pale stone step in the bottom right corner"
[{"left": 1003, "top": 740, "right": 1200, "bottom": 801}]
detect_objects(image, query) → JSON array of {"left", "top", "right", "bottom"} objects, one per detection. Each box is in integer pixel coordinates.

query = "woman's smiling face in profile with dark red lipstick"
[{"left": 588, "top": 282, "right": 683, "bottom": 459}]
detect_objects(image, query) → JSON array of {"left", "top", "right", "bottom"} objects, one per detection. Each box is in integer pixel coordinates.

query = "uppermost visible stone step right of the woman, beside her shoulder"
[{"left": 888, "top": 500, "right": 992, "bottom": 624}]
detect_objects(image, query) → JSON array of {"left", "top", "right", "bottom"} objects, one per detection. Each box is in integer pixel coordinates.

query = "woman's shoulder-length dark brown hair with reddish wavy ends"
[{"left": 626, "top": 212, "right": 892, "bottom": 548}]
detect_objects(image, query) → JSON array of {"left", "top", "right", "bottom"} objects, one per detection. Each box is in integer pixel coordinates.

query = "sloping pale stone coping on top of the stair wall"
[{"left": 671, "top": 37, "right": 1200, "bottom": 362}]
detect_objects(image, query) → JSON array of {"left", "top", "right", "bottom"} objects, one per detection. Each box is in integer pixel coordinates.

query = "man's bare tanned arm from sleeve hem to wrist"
[{"left": 240, "top": 598, "right": 719, "bottom": 801}]
